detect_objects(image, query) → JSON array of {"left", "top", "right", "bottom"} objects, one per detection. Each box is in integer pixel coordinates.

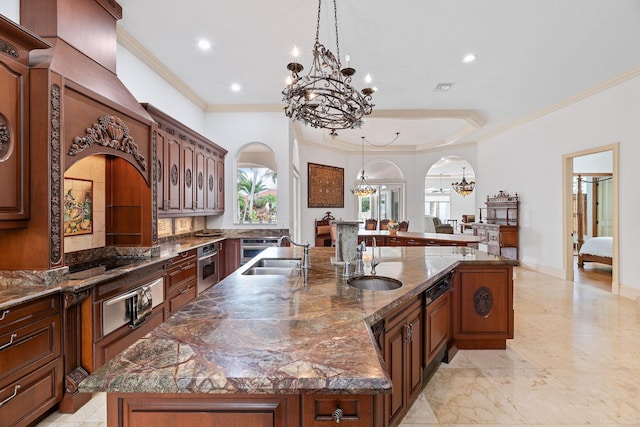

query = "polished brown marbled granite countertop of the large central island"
[{"left": 80, "top": 247, "right": 511, "bottom": 394}]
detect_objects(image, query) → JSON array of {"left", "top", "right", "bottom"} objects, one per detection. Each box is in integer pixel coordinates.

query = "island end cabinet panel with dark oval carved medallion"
[{"left": 452, "top": 265, "right": 514, "bottom": 349}]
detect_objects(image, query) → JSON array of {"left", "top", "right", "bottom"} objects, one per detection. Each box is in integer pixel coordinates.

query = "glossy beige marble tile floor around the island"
[{"left": 39, "top": 268, "right": 640, "bottom": 427}]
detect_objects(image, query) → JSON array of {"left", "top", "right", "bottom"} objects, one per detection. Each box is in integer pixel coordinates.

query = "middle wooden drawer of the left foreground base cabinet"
[{"left": 0, "top": 316, "right": 60, "bottom": 384}]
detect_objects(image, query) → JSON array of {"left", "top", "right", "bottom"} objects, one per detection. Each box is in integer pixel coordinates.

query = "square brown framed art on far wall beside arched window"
[{"left": 307, "top": 163, "right": 344, "bottom": 208}]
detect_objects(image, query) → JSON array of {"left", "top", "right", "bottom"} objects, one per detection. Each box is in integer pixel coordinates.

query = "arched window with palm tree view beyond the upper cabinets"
[{"left": 235, "top": 142, "right": 278, "bottom": 224}]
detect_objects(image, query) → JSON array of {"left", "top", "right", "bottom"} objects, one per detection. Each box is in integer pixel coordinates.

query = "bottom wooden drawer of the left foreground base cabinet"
[{"left": 0, "top": 357, "right": 63, "bottom": 427}]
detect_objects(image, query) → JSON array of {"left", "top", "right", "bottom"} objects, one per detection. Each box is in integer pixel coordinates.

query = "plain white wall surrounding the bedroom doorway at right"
[{"left": 477, "top": 73, "right": 640, "bottom": 296}]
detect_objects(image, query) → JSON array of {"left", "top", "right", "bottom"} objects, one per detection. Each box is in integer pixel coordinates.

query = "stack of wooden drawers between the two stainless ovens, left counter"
[{"left": 165, "top": 249, "right": 198, "bottom": 315}]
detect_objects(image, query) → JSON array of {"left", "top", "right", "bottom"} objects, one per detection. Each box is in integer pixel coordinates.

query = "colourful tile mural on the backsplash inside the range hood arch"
[{"left": 64, "top": 178, "right": 93, "bottom": 237}]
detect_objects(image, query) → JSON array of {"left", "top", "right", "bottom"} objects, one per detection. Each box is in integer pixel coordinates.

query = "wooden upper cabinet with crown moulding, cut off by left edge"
[{"left": 0, "top": 15, "right": 49, "bottom": 229}]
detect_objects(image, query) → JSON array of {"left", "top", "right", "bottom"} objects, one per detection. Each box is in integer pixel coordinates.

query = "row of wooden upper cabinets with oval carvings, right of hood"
[{"left": 142, "top": 104, "right": 227, "bottom": 217}]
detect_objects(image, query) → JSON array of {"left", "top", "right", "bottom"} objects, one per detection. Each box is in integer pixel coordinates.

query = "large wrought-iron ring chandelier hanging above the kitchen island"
[{"left": 282, "top": 0, "right": 375, "bottom": 130}]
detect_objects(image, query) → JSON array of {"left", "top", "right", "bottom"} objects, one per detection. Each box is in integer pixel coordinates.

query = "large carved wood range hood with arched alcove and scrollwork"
[{"left": 0, "top": 0, "right": 158, "bottom": 271}]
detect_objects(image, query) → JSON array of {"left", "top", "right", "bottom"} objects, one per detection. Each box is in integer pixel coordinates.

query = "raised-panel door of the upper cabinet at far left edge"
[{"left": 0, "top": 61, "right": 29, "bottom": 229}]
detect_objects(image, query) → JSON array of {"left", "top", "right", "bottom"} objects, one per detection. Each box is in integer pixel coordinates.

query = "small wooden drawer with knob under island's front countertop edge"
[{"left": 302, "top": 394, "right": 373, "bottom": 427}]
